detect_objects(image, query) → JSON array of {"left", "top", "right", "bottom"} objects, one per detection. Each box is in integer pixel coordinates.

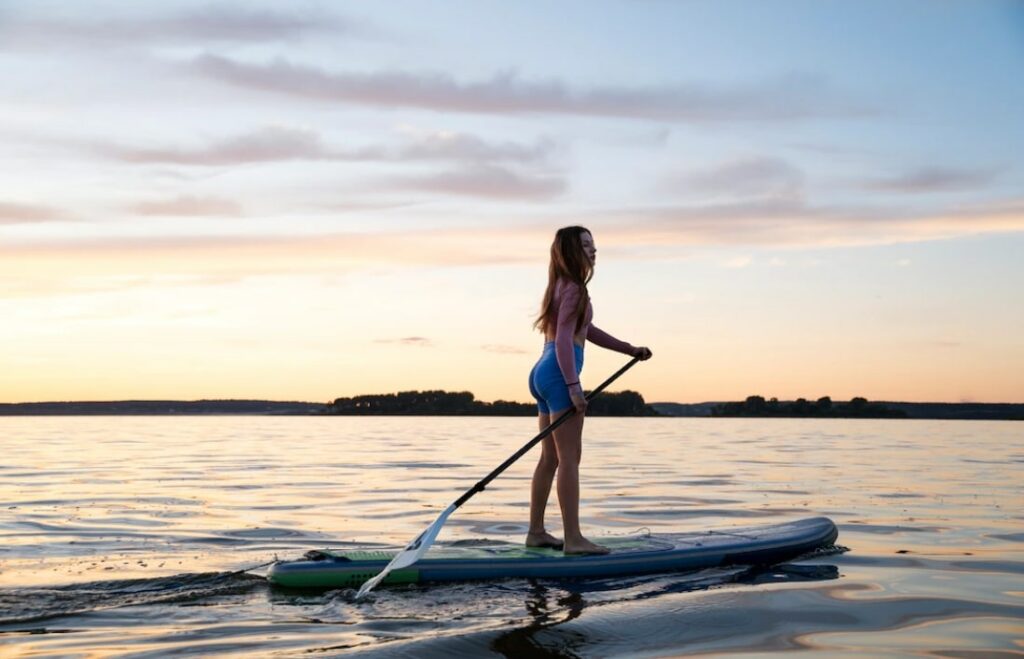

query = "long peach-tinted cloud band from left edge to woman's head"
[{"left": 0, "top": 223, "right": 550, "bottom": 300}]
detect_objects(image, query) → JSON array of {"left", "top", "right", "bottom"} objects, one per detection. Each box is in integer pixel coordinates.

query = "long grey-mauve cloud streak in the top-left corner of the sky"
[{"left": 3, "top": 5, "right": 366, "bottom": 49}]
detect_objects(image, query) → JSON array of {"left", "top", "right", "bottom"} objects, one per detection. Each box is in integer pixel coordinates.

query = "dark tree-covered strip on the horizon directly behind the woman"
[{"left": 327, "top": 390, "right": 658, "bottom": 416}]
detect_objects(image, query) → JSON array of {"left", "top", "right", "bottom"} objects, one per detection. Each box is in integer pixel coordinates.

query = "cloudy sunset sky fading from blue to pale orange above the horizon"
[{"left": 0, "top": 0, "right": 1024, "bottom": 402}]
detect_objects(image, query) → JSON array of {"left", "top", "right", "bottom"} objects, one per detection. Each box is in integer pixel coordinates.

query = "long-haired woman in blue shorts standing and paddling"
[{"left": 526, "top": 226, "right": 651, "bottom": 554}]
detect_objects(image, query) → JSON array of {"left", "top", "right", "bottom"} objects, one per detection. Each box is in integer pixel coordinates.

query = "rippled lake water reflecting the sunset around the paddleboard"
[{"left": 0, "top": 416, "right": 1024, "bottom": 658}]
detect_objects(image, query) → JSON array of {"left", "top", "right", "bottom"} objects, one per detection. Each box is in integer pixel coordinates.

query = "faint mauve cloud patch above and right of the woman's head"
[{"left": 672, "top": 158, "right": 804, "bottom": 199}]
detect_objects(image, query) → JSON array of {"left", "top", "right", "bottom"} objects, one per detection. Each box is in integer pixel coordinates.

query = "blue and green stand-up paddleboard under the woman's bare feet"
[{"left": 267, "top": 517, "right": 839, "bottom": 588}]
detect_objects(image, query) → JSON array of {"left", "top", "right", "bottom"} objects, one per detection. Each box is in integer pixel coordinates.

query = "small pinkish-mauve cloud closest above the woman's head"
[{"left": 388, "top": 166, "right": 566, "bottom": 202}]
